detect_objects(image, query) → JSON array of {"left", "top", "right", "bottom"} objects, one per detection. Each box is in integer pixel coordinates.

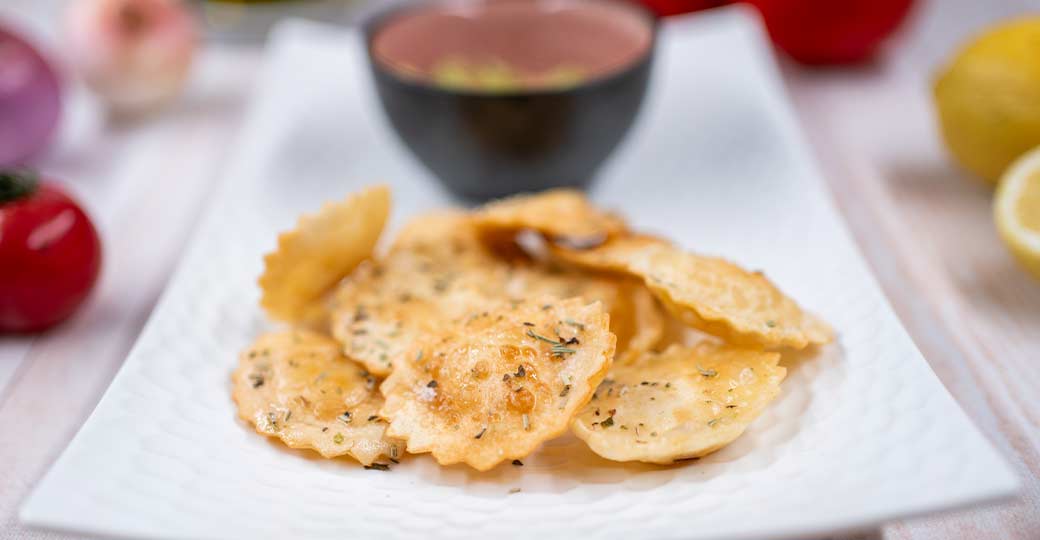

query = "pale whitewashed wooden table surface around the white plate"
[{"left": 0, "top": 0, "right": 1040, "bottom": 540}]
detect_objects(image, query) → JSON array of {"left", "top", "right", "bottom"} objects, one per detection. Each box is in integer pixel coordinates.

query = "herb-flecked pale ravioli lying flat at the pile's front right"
[{"left": 571, "top": 342, "right": 786, "bottom": 464}]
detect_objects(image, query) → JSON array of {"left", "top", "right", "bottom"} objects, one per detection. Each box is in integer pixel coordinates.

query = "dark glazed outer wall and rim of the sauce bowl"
[{"left": 365, "top": 0, "right": 656, "bottom": 200}]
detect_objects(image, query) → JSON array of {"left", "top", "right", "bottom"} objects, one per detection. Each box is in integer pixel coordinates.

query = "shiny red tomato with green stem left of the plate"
[{"left": 0, "top": 170, "right": 101, "bottom": 332}]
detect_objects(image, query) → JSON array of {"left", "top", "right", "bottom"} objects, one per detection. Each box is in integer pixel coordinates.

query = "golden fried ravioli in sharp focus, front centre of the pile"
[{"left": 381, "top": 298, "right": 615, "bottom": 470}]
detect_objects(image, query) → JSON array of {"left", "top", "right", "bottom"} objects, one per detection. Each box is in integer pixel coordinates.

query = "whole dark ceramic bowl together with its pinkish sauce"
[{"left": 366, "top": 0, "right": 656, "bottom": 199}]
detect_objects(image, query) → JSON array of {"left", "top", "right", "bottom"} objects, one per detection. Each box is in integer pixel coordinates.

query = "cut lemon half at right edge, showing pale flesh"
[{"left": 993, "top": 147, "right": 1040, "bottom": 278}]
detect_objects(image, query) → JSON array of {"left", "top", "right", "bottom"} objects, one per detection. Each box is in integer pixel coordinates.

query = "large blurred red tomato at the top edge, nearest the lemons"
[{"left": 745, "top": 0, "right": 913, "bottom": 65}]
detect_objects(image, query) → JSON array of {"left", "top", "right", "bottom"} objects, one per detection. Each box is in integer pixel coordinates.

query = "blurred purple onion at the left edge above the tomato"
[{"left": 0, "top": 25, "right": 61, "bottom": 168}]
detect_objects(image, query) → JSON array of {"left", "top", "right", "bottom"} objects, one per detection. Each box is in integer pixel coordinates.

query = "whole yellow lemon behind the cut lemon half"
[{"left": 934, "top": 17, "right": 1040, "bottom": 183}]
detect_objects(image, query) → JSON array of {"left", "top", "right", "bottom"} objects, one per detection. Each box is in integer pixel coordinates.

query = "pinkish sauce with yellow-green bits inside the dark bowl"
[{"left": 372, "top": 0, "right": 653, "bottom": 92}]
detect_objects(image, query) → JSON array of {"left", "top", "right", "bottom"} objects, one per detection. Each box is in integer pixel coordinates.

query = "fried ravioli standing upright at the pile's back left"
[{"left": 260, "top": 186, "right": 390, "bottom": 323}]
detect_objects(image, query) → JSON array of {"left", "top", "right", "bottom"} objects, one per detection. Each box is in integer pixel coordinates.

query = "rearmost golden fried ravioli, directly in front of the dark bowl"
[{"left": 473, "top": 189, "right": 626, "bottom": 246}]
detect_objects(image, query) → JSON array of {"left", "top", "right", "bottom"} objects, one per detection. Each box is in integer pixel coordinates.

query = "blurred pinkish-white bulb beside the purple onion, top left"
[{"left": 67, "top": 0, "right": 199, "bottom": 113}]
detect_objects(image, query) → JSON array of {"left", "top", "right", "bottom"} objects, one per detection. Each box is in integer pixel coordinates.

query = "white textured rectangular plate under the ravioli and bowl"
[{"left": 21, "top": 8, "right": 1017, "bottom": 540}]
